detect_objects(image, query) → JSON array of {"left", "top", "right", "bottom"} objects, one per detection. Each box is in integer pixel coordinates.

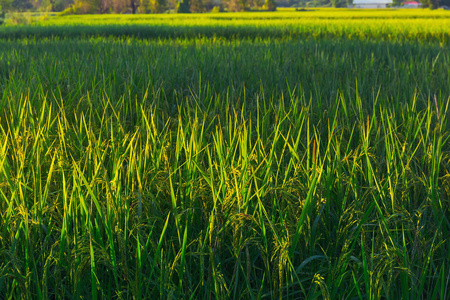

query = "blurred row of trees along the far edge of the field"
[{"left": 0, "top": 0, "right": 450, "bottom": 18}]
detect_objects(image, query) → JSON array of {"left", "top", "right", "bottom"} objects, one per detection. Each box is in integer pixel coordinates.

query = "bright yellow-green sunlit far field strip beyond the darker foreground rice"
[{"left": 0, "top": 9, "right": 450, "bottom": 45}]
